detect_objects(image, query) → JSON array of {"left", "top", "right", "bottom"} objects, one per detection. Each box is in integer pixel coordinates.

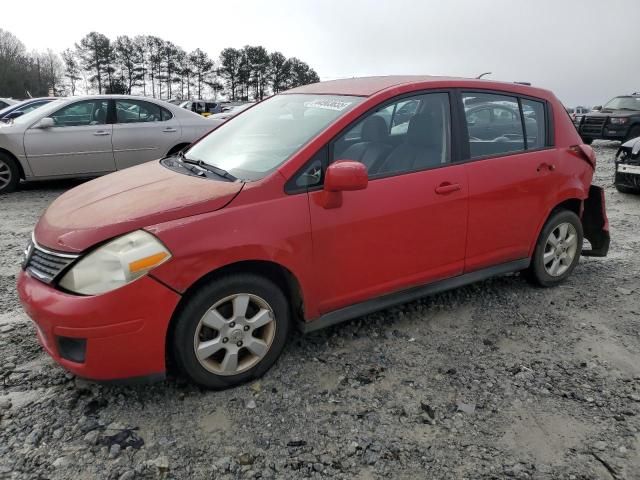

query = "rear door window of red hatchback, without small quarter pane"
[{"left": 463, "top": 93, "right": 525, "bottom": 158}]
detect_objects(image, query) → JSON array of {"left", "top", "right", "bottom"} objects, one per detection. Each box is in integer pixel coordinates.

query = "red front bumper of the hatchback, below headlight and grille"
[{"left": 18, "top": 271, "right": 180, "bottom": 380}]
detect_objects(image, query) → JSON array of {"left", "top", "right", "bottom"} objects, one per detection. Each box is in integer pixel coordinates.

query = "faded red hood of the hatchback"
[{"left": 35, "top": 161, "right": 244, "bottom": 252}]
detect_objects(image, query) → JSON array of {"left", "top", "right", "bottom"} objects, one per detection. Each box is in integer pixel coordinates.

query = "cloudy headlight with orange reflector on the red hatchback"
[{"left": 59, "top": 230, "right": 171, "bottom": 295}]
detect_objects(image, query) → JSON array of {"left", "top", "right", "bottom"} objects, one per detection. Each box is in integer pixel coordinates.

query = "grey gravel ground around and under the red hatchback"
[{"left": 0, "top": 143, "right": 640, "bottom": 480}]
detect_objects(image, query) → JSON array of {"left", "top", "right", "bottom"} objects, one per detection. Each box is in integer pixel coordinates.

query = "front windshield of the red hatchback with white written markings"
[{"left": 185, "top": 94, "right": 363, "bottom": 180}]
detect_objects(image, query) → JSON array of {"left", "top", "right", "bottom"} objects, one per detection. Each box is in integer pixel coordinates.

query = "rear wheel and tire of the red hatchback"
[{"left": 527, "top": 210, "right": 583, "bottom": 287}]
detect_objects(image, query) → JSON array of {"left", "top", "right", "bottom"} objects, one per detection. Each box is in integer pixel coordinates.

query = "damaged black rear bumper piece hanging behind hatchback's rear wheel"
[{"left": 582, "top": 185, "right": 611, "bottom": 257}]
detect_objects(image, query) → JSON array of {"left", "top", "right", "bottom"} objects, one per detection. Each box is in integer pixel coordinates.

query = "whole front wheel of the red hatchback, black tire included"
[{"left": 171, "top": 274, "right": 291, "bottom": 390}]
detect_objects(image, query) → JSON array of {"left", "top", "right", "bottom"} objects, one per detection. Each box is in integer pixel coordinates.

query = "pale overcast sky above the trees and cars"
[{"left": 0, "top": 0, "right": 640, "bottom": 106}]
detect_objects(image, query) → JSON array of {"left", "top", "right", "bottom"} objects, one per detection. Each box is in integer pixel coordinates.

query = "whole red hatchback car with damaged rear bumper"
[{"left": 18, "top": 77, "right": 609, "bottom": 388}]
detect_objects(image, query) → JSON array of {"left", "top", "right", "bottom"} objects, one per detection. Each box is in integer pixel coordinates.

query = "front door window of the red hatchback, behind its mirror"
[{"left": 332, "top": 93, "right": 451, "bottom": 177}]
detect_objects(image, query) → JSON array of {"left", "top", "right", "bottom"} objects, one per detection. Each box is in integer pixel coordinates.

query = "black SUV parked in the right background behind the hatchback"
[{"left": 577, "top": 93, "right": 640, "bottom": 144}]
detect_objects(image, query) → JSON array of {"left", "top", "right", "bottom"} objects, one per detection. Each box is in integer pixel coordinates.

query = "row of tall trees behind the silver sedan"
[{"left": 0, "top": 29, "right": 320, "bottom": 100}]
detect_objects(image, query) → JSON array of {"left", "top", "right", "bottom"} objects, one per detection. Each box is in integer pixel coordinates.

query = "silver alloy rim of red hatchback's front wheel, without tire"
[{"left": 193, "top": 293, "right": 276, "bottom": 376}]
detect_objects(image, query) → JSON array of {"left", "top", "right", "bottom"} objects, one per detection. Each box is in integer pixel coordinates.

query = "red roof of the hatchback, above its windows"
[{"left": 283, "top": 75, "right": 550, "bottom": 97}]
